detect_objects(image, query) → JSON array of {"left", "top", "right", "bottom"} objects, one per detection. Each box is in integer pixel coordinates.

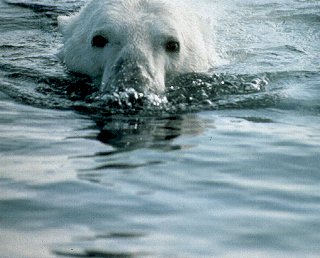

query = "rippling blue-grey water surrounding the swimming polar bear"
[{"left": 0, "top": 0, "right": 320, "bottom": 257}]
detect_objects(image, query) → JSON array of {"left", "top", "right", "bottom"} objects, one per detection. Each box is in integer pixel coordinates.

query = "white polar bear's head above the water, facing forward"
[{"left": 58, "top": 0, "right": 214, "bottom": 94}]
